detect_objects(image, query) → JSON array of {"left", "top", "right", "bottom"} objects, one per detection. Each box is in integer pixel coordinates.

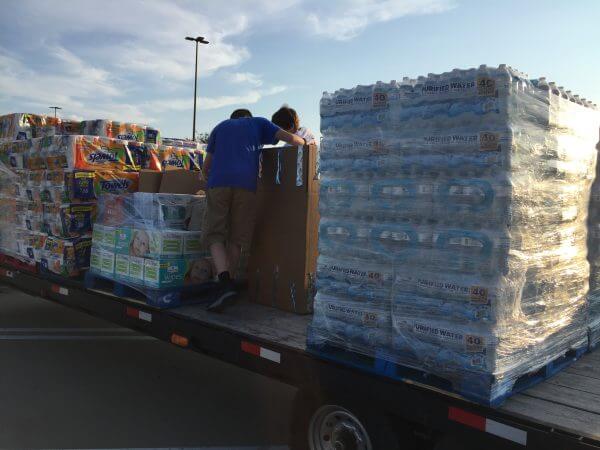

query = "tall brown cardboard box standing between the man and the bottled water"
[{"left": 248, "top": 146, "right": 319, "bottom": 314}]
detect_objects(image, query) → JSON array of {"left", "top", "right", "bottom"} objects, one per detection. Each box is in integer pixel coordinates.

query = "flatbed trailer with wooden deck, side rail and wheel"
[{"left": 0, "top": 268, "right": 600, "bottom": 450}]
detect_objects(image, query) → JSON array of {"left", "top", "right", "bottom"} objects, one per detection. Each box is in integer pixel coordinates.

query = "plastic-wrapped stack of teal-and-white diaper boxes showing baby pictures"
[{"left": 90, "top": 192, "right": 214, "bottom": 307}]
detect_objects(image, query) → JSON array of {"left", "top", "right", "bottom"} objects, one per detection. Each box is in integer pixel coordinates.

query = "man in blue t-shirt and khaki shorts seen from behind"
[{"left": 203, "top": 109, "right": 306, "bottom": 312}]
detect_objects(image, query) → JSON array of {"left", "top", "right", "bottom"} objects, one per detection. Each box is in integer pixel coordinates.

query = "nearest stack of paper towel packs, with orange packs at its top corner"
[{"left": 0, "top": 135, "right": 138, "bottom": 276}]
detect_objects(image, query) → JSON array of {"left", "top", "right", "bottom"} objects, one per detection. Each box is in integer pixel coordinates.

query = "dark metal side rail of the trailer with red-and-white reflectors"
[{"left": 0, "top": 267, "right": 600, "bottom": 450}]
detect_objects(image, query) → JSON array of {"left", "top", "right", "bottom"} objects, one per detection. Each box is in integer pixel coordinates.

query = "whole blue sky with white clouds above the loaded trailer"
[{"left": 0, "top": 0, "right": 600, "bottom": 137}]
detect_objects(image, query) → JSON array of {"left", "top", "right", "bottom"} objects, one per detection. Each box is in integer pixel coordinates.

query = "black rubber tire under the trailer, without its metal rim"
[{"left": 289, "top": 390, "right": 416, "bottom": 450}]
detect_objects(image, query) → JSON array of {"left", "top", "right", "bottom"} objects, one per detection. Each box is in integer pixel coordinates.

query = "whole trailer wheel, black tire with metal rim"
[{"left": 290, "top": 391, "right": 415, "bottom": 450}]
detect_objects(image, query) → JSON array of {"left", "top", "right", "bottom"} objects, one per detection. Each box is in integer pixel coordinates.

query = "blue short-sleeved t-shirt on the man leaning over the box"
[{"left": 206, "top": 117, "right": 279, "bottom": 191}]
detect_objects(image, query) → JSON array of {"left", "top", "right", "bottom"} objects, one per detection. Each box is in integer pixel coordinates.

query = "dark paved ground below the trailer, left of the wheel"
[{"left": 0, "top": 285, "right": 295, "bottom": 450}]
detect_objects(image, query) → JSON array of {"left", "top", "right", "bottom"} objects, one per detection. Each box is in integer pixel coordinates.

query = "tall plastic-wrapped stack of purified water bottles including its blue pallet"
[{"left": 309, "top": 65, "right": 600, "bottom": 404}]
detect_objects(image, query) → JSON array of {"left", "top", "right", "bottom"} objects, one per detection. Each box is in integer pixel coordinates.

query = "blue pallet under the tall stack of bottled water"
[{"left": 307, "top": 326, "right": 588, "bottom": 407}]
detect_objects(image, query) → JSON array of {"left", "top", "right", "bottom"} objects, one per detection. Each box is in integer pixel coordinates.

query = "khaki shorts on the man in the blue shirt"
[{"left": 204, "top": 187, "right": 256, "bottom": 248}]
